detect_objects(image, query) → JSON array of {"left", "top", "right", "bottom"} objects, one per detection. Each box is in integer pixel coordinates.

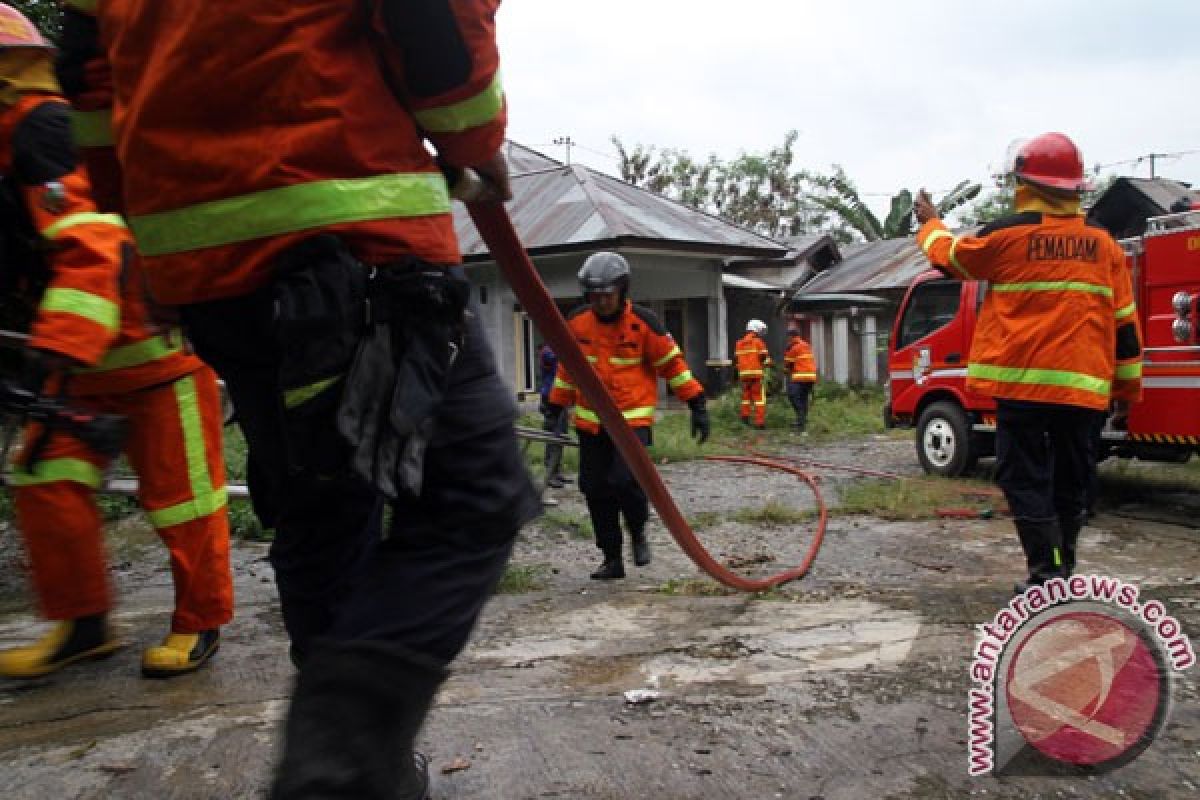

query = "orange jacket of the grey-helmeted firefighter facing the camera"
[{"left": 550, "top": 300, "right": 704, "bottom": 433}]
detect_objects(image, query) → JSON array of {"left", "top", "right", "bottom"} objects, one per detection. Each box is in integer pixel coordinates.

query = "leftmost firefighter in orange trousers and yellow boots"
[{"left": 0, "top": 5, "right": 233, "bottom": 678}]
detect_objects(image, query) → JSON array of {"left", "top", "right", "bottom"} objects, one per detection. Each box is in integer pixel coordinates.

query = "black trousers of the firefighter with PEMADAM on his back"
[{"left": 996, "top": 399, "right": 1102, "bottom": 525}]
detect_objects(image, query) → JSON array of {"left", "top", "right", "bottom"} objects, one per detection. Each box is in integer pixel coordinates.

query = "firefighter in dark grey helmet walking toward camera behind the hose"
[{"left": 550, "top": 252, "right": 709, "bottom": 581}]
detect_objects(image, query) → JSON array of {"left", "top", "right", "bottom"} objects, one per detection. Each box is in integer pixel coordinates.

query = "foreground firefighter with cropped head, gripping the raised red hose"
[{"left": 64, "top": 0, "right": 540, "bottom": 799}]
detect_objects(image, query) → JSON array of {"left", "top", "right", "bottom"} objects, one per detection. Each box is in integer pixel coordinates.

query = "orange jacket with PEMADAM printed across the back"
[{"left": 917, "top": 211, "right": 1141, "bottom": 410}]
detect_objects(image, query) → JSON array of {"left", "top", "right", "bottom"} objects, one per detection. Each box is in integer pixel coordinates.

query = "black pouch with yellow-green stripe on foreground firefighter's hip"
[{"left": 272, "top": 234, "right": 370, "bottom": 477}]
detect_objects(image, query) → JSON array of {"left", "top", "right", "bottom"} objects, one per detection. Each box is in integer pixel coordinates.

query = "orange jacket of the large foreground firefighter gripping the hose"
[{"left": 61, "top": 0, "right": 506, "bottom": 303}]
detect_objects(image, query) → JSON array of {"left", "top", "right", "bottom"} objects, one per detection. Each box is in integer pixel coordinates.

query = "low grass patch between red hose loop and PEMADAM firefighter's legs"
[{"left": 832, "top": 477, "right": 1003, "bottom": 519}]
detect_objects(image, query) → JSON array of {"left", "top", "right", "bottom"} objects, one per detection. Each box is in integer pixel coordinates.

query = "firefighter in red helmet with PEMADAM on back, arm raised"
[{"left": 914, "top": 133, "right": 1141, "bottom": 591}]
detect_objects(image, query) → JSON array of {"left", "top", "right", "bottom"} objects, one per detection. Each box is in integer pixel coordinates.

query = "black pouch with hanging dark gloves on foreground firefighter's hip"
[{"left": 337, "top": 259, "right": 470, "bottom": 499}]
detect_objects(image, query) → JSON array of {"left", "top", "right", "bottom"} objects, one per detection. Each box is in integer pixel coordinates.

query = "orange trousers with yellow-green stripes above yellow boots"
[{"left": 12, "top": 367, "right": 233, "bottom": 633}]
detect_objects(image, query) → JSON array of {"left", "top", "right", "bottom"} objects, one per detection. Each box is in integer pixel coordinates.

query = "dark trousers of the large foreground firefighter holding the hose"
[{"left": 182, "top": 272, "right": 540, "bottom": 664}]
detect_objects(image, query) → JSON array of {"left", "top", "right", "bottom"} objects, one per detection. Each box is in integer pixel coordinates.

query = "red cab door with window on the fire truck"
[{"left": 888, "top": 278, "right": 971, "bottom": 419}]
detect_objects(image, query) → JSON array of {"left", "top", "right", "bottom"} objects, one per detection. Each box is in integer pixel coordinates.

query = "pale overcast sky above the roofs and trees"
[{"left": 498, "top": 0, "right": 1200, "bottom": 215}]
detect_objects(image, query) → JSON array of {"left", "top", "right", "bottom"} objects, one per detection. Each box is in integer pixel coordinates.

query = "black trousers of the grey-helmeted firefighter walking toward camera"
[{"left": 578, "top": 427, "right": 653, "bottom": 558}]
